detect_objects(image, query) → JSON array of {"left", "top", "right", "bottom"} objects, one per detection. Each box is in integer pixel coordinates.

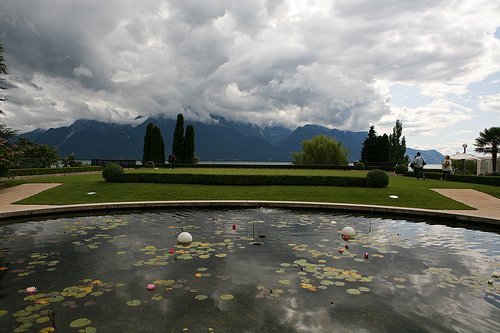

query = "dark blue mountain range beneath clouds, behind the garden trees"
[{"left": 20, "top": 115, "right": 443, "bottom": 163}]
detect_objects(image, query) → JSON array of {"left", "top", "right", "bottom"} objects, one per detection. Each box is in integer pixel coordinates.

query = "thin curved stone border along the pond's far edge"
[{"left": 0, "top": 200, "right": 500, "bottom": 226}]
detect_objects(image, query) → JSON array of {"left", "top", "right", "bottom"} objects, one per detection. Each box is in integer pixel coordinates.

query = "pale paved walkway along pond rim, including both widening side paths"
[{"left": 0, "top": 183, "right": 500, "bottom": 225}]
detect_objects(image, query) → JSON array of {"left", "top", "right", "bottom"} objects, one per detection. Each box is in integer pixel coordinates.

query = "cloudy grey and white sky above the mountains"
[{"left": 0, "top": 0, "right": 500, "bottom": 154}]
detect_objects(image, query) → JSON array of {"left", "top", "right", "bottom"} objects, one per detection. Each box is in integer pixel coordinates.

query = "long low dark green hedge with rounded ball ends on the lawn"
[{"left": 102, "top": 173, "right": 390, "bottom": 187}]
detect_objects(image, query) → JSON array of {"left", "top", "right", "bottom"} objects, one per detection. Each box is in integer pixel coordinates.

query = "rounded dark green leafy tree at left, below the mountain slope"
[{"left": 16, "top": 138, "right": 59, "bottom": 168}]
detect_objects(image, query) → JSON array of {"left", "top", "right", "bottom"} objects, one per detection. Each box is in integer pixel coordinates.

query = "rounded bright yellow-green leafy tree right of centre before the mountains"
[{"left": 292, "top": 135, "right": 349, "bottom": 165}]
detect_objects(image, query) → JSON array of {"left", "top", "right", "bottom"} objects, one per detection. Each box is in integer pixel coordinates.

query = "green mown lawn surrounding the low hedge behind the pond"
[{"left": 5, "top": 168, "right": 500, "bottom": 209}]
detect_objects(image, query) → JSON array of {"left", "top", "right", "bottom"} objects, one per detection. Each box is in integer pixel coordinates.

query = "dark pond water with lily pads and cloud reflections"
[{"left": 0, "top": 208, "right": 500, "bottom": 333}]
